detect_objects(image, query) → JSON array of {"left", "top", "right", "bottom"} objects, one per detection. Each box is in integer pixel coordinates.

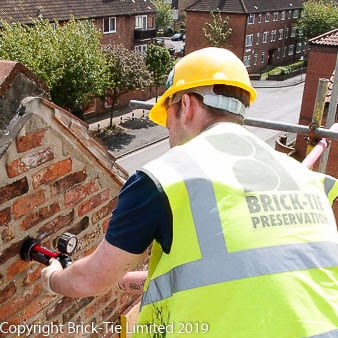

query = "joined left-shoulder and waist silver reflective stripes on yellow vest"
[{"left": 142, "top": 134, "right": 338, "bottom": 306}]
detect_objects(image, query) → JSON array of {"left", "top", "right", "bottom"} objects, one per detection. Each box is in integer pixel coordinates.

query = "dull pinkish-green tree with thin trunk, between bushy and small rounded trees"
[{"left": 102, "top": 44, "right": 150, "bottom": 128}]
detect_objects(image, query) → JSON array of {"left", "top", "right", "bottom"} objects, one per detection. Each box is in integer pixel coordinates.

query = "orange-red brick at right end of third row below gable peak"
[{"left": 32, "top": 158, "right": 72, "bottom": 189}]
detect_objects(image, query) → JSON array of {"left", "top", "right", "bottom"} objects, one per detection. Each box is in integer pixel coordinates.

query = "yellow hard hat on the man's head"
[{"left": 149, "top": 47, "right": 256, "bottom": 126}]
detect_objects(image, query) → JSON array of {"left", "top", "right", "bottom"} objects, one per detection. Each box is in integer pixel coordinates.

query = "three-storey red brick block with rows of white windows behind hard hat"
[{"left": 185, "top": 0, "right": 306, "bottom": 74}]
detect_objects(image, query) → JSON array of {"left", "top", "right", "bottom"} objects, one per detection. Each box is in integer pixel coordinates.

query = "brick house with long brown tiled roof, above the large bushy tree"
[{"left": 0, "top": 0, "right": 156, "bottom": 51}]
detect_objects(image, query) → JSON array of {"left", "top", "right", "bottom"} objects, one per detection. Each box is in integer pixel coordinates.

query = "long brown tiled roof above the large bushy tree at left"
[{"left": 0, "top": 0, "right": 156, "bottom": 23}]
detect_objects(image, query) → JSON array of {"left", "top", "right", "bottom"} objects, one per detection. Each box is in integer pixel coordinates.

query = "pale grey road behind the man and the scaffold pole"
[{"left": 117, "top": 83, "right": 304, "bottom": 174}]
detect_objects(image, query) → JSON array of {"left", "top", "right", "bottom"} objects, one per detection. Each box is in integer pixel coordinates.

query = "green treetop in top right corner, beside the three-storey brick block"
[{"left": 296, "top": 0, "right": 338, "bottom": 39}]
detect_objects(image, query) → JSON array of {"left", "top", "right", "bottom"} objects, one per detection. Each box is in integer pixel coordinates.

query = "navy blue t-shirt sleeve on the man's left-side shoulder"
[{"left": 105, "top": 171, "right": 172, "bottom": 254}]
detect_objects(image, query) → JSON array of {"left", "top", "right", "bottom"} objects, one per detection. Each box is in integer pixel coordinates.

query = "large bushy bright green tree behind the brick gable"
[{"left": 0, "top": 18, "right": 105, "bottom": 110}]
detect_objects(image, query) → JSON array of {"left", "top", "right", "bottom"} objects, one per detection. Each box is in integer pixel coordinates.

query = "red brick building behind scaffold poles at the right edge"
[{"left": 296, "top": 29, "right": 338, "bottom": 219}]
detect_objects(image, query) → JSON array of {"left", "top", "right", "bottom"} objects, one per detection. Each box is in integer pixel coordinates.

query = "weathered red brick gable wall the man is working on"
[{"left": 0, "top": 99, "right": 141, "bottom": 337}]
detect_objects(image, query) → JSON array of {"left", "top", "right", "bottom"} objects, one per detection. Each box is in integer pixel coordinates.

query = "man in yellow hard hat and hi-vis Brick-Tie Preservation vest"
[{"left": 43, "top": 48, "right": 338, "bottom": 338}]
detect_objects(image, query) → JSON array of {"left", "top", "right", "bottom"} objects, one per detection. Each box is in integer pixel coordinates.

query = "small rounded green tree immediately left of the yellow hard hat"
[{"left": 146, "top": 45, "right": 174, "bottom": 100}]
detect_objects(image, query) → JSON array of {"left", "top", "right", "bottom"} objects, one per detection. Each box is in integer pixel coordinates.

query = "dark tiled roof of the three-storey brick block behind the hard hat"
[{"left": 186, "top": 0, "right": 304, "bottom": 14}]
